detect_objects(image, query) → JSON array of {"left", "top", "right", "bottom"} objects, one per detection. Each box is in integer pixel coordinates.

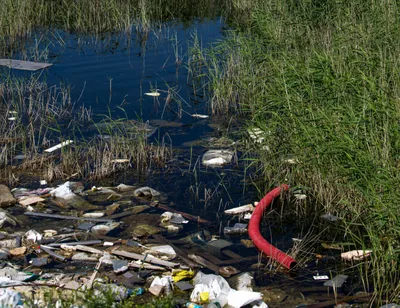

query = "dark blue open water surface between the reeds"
[{"left": 1, "top": 15, "right": 360, "bottom": 307}]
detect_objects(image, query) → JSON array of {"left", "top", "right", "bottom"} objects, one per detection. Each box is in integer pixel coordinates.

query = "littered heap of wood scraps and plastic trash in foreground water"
[{"left": 0, "top": 182, "right": 390, "bottom": 308}]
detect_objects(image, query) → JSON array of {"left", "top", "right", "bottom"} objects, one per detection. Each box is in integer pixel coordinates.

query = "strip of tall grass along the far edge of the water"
[{"left": 0, "top": 0, "right": 233, "bottom": 54}]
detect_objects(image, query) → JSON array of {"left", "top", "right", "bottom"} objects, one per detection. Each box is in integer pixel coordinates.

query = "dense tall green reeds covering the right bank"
[{"left": 198, "top": 0, "right": 400, "bottom": 300}]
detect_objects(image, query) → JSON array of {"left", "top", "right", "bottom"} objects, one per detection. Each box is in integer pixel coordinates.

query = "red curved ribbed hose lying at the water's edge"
[{"left": 249, "top": 184, "right": 296, "bottom": 269}]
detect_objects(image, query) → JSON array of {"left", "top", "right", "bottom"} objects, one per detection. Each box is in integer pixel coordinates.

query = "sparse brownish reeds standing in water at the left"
[{"left": 0, "top": 75, "right": 172, "bottom": 184}]
